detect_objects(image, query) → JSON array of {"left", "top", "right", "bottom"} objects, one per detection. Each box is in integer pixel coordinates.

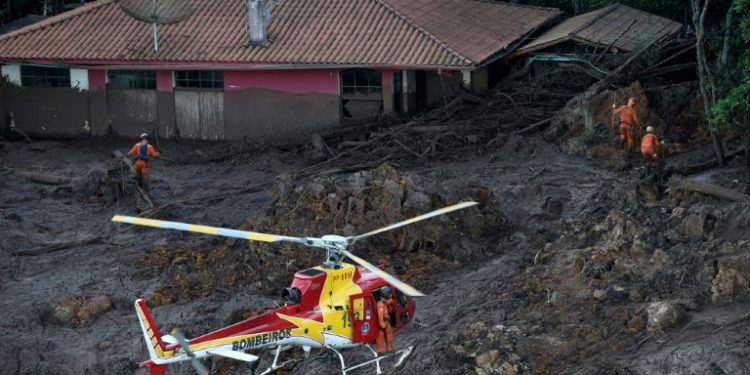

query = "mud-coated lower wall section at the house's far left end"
[{"left": 3, "top": 84, "right": 89, "bottom": 136}]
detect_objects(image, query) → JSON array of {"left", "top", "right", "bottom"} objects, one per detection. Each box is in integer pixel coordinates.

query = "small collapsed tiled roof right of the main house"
[{"left": 513, "top": 4, "right": 682, "bottom": 56}]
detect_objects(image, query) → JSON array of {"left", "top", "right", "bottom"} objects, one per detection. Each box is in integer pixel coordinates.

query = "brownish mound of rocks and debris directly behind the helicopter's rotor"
[{"left": 137, "top": 164, "right": 509, "bottom": 305}]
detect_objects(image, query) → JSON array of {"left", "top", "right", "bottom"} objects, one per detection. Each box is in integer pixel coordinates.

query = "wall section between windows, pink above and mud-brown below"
[{"left": 224, "top": 69, "right": 340, "bottom": 142}]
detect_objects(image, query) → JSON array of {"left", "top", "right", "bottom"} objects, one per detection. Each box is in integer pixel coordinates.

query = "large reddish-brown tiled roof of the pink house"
[{"left": 0, "top": 0, "right": 559, "bottom": 68}]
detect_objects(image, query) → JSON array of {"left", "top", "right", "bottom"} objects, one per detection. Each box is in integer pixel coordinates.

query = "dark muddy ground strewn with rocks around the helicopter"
[{"left": 0, "top": 96, "right": 750, "bottom": 375}]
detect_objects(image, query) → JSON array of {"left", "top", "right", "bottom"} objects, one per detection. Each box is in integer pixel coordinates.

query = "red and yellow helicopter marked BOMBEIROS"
[{"left": 112, "top": 202, "right": 478, "bottom": 375}]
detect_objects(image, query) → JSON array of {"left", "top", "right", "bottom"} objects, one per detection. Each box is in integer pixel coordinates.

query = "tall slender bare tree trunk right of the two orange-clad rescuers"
[{"left": 690, "top": 0, "right": 724, "bottom": 167}]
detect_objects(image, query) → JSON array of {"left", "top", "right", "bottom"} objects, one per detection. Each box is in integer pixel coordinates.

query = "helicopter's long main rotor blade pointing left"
[{"left": 112, "top": 215, "right": 305, "bottom": 243}]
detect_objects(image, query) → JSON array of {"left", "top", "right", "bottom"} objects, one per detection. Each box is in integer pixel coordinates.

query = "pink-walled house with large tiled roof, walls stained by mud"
[{"left": 0, "top": 0, "right": 560, "bottom": 141}]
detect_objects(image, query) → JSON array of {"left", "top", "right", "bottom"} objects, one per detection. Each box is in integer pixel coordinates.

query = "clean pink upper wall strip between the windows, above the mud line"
[{"left": 224, "top": 69, "right": 339, "bottom": 95}]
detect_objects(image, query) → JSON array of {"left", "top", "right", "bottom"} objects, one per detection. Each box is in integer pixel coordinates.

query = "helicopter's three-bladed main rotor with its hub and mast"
[{"left": 112, "top": 202, "right": 478, "bottom": 297}]
